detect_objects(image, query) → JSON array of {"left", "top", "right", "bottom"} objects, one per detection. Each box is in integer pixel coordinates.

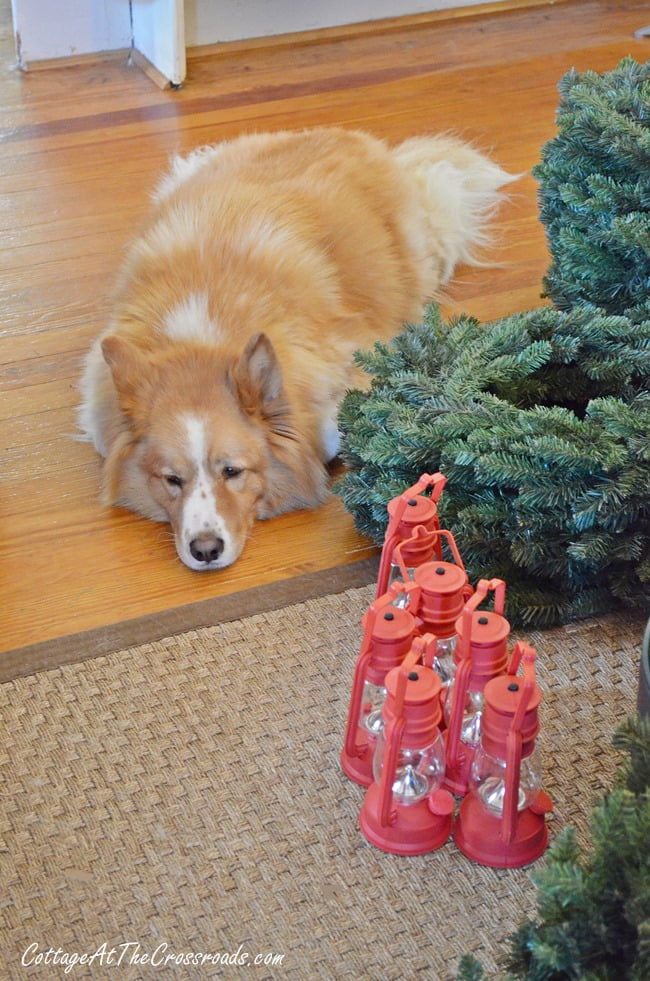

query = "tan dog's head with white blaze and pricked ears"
[{"left": 102, "top": 334, "right": 325, "bottom": 570}]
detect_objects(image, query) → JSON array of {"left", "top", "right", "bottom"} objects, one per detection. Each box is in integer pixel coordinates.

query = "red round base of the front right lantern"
[{"left": 454, "top": 791, "right": 552, "bottom": 869}]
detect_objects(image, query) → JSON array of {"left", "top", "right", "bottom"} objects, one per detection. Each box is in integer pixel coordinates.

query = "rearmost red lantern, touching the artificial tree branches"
[{"left": 375, "top": 473, "right": 447, "bottom": 596}]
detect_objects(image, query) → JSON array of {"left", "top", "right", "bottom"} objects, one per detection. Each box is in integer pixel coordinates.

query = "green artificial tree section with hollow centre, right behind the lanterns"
[{"left": 338, "top": 306, "right": 650, "bottom": 625}]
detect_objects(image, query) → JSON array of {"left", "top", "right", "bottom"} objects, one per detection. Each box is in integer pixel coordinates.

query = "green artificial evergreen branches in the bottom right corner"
[{"left": 458, "top": 719, "right": 650, "bottom": 981}]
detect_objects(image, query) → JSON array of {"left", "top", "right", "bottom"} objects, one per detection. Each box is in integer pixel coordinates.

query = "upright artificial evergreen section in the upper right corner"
[{"left": 533, "top": 58, "right": 650, "bottom": 320}]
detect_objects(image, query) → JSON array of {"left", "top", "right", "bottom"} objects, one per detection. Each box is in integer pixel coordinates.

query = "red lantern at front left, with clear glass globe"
[{"left": 359, "top": 656, "right": 454, "bottom": 855}]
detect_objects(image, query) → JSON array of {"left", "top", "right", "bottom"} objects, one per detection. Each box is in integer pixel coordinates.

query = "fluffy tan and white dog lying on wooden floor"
[{"left": 79, "top": 127, "right": 514, "bottom": 571}]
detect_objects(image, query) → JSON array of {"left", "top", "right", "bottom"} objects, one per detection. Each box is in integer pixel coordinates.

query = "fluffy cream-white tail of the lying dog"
[{"left": 392, "top": 136, "right": 520, "bottom": 292}]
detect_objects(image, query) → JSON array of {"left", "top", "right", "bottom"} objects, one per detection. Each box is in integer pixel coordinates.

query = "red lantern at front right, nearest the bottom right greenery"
[{"left": 454, "top": 643, "right": 553, "bottom": 868}]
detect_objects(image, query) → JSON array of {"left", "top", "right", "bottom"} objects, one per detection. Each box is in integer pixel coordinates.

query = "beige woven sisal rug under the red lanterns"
[{"left": 0, "top": 587, "right": 643, "bottom": 981}]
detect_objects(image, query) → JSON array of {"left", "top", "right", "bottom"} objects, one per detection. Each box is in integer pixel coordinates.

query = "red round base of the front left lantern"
[{"left": 359, "top": 783, "right": 454, "bottom": 855}]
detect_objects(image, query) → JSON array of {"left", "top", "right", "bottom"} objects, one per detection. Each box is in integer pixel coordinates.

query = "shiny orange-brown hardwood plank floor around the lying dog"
[{"left": 0, "top": 0, "right": 650, "bottom": 662}]
